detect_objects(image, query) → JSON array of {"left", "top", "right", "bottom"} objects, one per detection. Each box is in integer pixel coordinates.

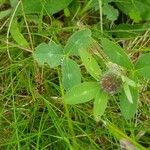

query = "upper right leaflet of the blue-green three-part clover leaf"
[{"left": 64, "top": 29, "right": 92, "bottom": 54}]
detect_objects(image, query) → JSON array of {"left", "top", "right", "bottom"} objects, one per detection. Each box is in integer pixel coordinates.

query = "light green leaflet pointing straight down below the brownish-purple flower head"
[{"left": 93, "top": 91, "right": 108, "bottom": 121}]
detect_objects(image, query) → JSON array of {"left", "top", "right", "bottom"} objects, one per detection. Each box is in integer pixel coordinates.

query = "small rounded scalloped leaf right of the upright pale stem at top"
[{"left": 103, "top": 4, "right": 119, "bottom": 21}]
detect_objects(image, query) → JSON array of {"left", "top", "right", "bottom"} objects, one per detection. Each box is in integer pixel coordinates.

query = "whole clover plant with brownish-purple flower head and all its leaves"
[{"left": 33, "top": 28, "right": 150, "bottom": 121}]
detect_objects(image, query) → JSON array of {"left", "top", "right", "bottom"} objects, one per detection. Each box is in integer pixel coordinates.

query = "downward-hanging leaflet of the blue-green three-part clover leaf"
[{"left": 62, "top": 59, "right": 81, "bottom": 90}]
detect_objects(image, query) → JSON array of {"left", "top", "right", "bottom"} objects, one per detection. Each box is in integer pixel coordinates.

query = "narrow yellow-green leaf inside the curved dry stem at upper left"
[{"left": 10, "top": 19, "right": 29, "bottom": 47}]
